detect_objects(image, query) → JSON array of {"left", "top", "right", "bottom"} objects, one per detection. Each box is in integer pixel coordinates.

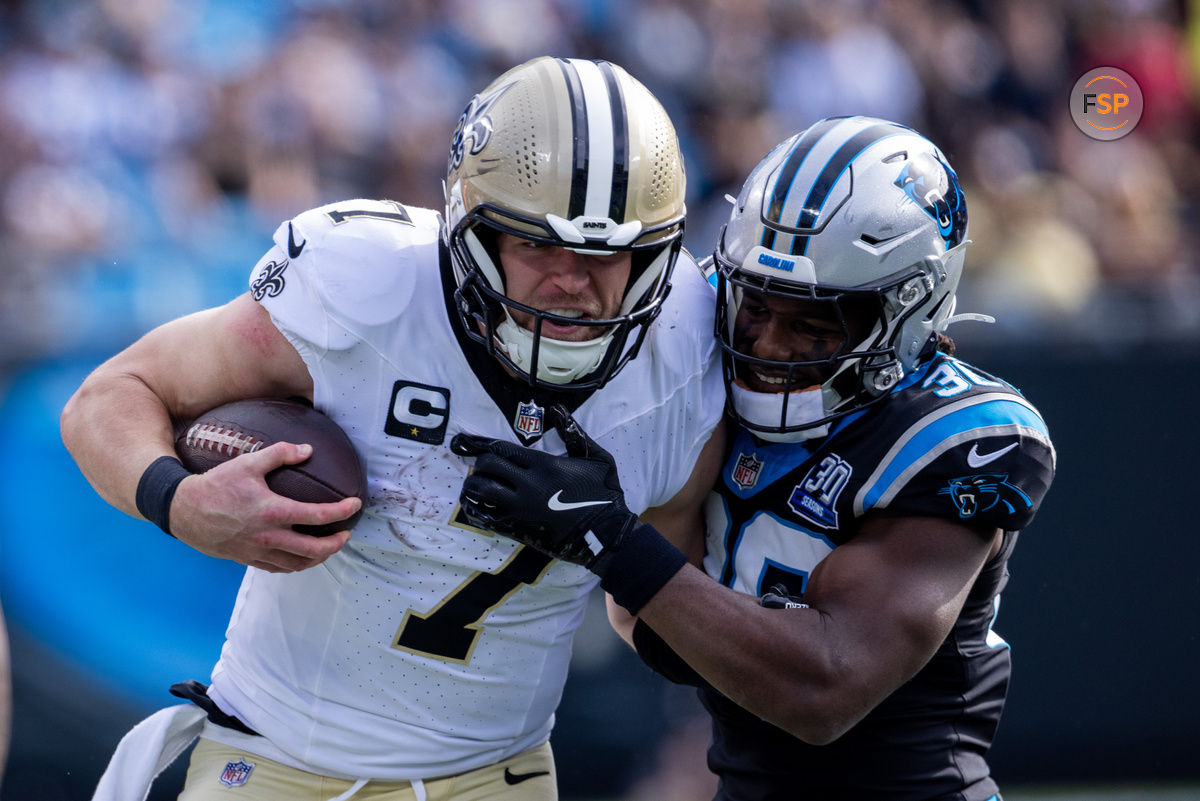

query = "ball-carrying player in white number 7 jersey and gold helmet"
[{"left": 62, "top": 58, "right": 724, "bottom": 801}]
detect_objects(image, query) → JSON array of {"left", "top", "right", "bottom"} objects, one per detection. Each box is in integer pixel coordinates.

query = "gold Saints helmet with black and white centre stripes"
[{"left": 445, "top": 58, "right": 685, "bottom": 389}]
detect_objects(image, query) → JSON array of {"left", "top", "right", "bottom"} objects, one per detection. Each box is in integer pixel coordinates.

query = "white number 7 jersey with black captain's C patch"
[{"left": 206, "top": 200, "right": 724, "bottom": 779}]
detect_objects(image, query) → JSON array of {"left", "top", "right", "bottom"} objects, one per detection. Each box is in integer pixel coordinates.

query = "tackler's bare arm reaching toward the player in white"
[{"left": 640, "top": 516, "right": 998, "bottom": 745}]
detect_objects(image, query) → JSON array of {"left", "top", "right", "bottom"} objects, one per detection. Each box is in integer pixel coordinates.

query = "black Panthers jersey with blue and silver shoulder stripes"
[{"left": 701, "top": 355, "right": 1055, "bottom": 801}]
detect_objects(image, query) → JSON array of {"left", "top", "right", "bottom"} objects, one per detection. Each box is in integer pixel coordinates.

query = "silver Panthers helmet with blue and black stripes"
[{"left": 714, "top": 116, "right": 985, "bottom": 441}]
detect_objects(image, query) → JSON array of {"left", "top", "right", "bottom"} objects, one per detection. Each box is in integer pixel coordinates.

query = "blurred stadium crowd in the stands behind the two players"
[{"left": 0, "top": 0, "right": 1200, "bottom": 366}]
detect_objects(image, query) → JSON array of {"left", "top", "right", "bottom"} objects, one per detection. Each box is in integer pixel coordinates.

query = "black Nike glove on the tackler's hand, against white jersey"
[{"left": 450, "top": 405, "right": 637, "bottom": 579}]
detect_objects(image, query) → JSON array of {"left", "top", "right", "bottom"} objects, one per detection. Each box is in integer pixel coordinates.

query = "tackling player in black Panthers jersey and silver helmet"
[{"left": 453, "top": 118, "right": 1055, "bottom": 801}]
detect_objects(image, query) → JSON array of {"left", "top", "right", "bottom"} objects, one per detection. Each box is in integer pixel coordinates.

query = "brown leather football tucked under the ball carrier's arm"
[{"left": 175, "top": 398, "right": 367, "bottom": 537}]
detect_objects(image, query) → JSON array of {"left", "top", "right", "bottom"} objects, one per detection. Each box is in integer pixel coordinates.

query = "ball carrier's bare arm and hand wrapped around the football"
[{"left": 61, "top": 295, "right": 359, "bottom": 571}]
